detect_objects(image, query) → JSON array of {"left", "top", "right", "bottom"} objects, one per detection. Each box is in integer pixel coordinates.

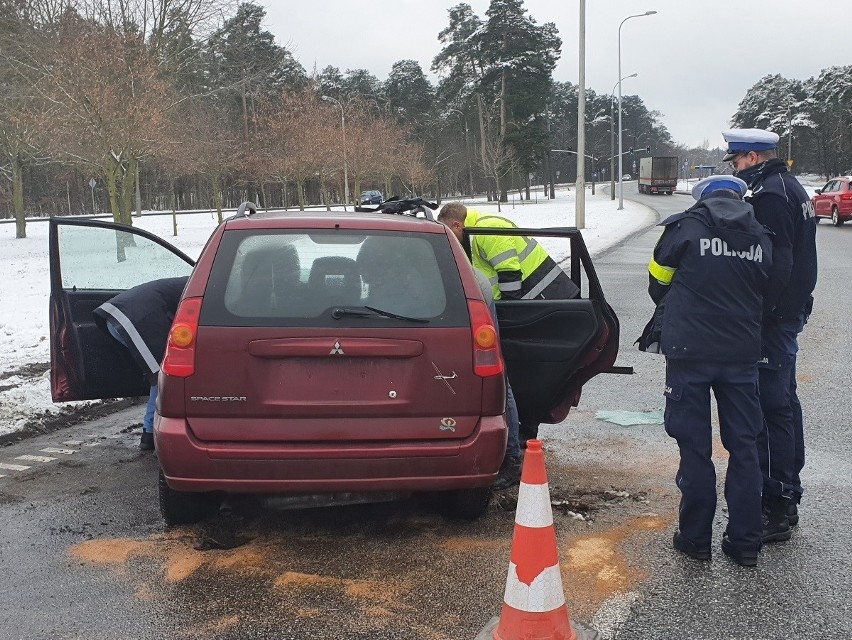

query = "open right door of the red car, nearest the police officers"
[{"left": 465, "top": 227, "right": 620, "bottom": 424}]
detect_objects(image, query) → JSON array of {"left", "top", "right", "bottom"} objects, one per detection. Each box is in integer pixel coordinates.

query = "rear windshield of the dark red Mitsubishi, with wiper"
[{"left": 200, "top": 229, "right": 468, "bottom": 327}]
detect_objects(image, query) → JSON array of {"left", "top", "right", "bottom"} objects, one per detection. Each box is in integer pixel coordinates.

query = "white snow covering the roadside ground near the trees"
[{"left": 0, "top": 182, "right": 656, "bottom": 435}]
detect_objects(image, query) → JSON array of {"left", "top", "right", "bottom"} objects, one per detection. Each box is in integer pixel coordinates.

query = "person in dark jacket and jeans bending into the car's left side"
[{"left": 93, "top": 277, "right": 188, "bottom": 451}]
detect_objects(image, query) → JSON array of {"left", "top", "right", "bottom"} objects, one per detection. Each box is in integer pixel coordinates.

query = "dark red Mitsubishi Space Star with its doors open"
[{"left": 50, "top": 202, "right": 619, "bottom": 524}]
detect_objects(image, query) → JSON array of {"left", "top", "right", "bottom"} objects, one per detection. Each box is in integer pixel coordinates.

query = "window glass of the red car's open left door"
[{"left": 58, "top": 224, "right": 192, "bottom": 290}]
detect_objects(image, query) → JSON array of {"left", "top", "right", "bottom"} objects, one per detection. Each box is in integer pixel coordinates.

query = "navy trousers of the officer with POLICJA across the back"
[{"left": 665, "top": 359, "right": 763, "bottom": 551}]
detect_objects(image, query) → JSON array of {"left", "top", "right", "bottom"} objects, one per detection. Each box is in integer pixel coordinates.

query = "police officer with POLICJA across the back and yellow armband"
[{"left": 640, "top": 176, "right": 772, "bottom": 566}]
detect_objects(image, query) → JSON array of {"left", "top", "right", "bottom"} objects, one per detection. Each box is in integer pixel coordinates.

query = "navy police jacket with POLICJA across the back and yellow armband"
[{"left": 640, "top": 191, "right": 772, "bottom": 362}]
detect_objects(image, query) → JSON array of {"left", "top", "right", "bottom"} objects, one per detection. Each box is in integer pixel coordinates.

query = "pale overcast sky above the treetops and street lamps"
[{"left": 260, "top": 0, "right": 852, "bottom": 148}]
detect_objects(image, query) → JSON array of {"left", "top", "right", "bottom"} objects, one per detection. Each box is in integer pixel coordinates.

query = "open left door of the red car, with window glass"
[{"left": 50, "top": 218, "right": 195, "bottom": 402}]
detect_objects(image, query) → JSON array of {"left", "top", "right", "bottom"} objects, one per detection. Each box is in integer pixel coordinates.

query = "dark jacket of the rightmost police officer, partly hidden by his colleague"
[{"left": 737, "top": 158, "right": 817, "bottom": 323}]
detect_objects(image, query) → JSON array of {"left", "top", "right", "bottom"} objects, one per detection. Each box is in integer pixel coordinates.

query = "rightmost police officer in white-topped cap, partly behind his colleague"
[{"left": 723, "top": 129, "right": 817, "bottom": 542}]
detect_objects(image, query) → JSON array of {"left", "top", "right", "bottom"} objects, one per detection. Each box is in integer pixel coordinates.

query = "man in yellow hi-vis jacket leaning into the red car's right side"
[{"left": 438, "top": 202, "right": 580, "bottom": 300}]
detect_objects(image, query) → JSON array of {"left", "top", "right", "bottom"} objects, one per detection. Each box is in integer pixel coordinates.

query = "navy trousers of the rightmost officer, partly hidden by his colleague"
[{"left": 757, "top": 317, "right": 805, "bottom": 502}]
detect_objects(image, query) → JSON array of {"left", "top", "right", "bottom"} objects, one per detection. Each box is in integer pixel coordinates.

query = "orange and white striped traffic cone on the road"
[{"left": 492, "top": 440, "right": 577, "bottom": 640}]
